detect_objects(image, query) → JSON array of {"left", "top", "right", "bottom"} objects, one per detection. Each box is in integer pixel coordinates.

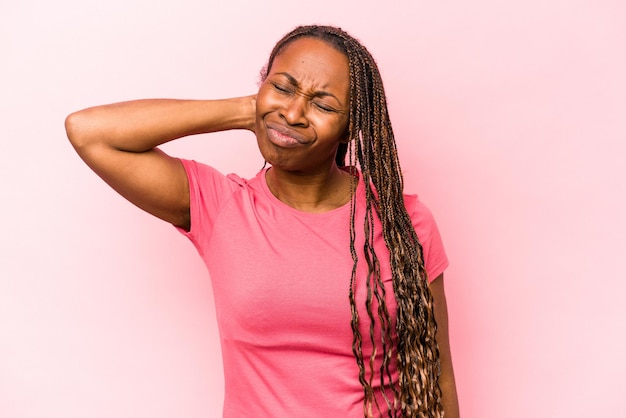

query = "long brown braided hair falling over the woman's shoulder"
[{"left": 261, "top": 26, "right": 443, "bottom": 418}]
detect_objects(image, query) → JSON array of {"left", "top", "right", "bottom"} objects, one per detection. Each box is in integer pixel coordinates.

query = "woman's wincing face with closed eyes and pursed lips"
[{"left": 256, "top": 38, "right": 350, "bottom": 174}]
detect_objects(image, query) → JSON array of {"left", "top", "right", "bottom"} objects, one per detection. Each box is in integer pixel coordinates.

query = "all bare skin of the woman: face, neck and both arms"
[{"left": 65, "top": 33, "right": 459, "bottom": 418}]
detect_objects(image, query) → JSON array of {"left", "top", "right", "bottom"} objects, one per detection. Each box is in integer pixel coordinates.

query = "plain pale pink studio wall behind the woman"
[{"left": 0, "top": 0, "right": 626, "bottom": 418}]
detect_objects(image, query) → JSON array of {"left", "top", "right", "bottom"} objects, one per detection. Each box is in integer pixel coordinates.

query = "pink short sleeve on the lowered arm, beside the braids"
[{"left": 405, "top": 195, "right": 449, "bottom": 282}]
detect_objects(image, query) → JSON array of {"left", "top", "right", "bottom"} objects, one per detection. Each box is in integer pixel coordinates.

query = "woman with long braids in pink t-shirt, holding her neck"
[{"left": 66, "top": 26, "right": 458, "bottom": 417}]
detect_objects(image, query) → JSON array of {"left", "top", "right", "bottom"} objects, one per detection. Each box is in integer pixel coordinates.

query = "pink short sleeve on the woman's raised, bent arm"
[{"left": 177, "top": 159, "right": 241, "bottom": 255}]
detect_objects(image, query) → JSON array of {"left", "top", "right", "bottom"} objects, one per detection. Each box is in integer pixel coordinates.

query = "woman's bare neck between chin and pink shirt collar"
[{"left": 265, "top": 166, "right": 351, "bottom": 212}]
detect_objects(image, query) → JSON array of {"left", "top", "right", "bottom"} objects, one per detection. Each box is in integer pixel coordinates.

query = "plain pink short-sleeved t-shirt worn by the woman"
[{"left": 182, "top": 160, "right": 448, "bottom": 418}]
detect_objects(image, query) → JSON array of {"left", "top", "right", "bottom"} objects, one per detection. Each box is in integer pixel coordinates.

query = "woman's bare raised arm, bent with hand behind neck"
[{"left": 65, "top": 96, "right": 256, "bottom": 229}]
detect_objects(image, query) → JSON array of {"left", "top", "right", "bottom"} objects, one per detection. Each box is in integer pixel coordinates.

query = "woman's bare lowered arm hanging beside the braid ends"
[{"left": 430, "top": 274, "right": 459, "bottom": 418}]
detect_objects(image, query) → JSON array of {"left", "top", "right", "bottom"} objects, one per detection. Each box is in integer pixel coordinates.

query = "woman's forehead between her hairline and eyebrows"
[{"left": 269, "top": 38, "right": 350, "bottom": 91}]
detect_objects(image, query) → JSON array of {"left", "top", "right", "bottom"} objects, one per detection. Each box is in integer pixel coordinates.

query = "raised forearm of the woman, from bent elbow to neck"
[{"left": 65, "top": 97, "right": 254, "bottom": 152}]
